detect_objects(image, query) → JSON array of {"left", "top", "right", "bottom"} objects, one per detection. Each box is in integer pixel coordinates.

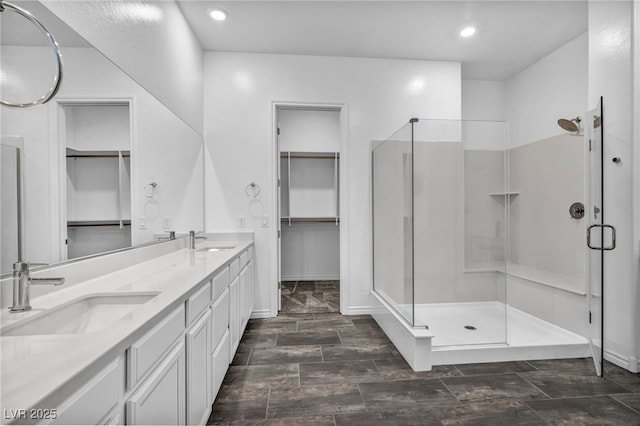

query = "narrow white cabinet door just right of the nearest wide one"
[{"left": 186, "top": 310, "right": 211, "bottom": 425}]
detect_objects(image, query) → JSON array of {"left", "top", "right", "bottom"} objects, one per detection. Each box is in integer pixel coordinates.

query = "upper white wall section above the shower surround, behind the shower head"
[{"left": 506, "top": 33, "right": 594, "bottom": 147}]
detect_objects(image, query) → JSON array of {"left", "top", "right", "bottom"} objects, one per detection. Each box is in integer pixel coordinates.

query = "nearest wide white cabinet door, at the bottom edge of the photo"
[{"left": 126, "top": 341, "right": 186, "bottom": 425}]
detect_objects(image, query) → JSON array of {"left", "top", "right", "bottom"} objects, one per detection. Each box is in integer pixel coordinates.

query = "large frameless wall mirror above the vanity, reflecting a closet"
[{"left": 0, "top": 1, "right": 204, "bottom": 274}]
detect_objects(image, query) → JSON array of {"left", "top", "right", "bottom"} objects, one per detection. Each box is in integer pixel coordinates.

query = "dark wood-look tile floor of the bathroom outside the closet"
[{"left": 208, "top": 313, "right": 640, "bottom": 426}]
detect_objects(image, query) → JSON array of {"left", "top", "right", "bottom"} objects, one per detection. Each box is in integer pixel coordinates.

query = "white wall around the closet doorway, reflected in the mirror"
[{"left": 1, "top": 46, "right": 204, "bottom": 262}]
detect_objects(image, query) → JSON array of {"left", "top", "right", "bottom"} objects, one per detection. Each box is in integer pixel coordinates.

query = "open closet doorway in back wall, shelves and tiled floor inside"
[{"left": 272, "top": 103, "right": 346, "bottom": 313}]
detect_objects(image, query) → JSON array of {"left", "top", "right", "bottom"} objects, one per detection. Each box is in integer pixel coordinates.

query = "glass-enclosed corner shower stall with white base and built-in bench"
[{"left": 371, "top": 113, "right": 601, "bottom": 371}]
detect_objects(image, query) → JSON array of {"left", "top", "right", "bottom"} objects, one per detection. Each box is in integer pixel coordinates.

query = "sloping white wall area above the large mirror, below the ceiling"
[{"left": 40, "top": 0, "right": 202, "bottom": 133}]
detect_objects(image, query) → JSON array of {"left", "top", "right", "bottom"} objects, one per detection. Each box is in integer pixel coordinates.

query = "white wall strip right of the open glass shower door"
[{"left": 589, "top": 1, "right": 640, "bottom": 371}]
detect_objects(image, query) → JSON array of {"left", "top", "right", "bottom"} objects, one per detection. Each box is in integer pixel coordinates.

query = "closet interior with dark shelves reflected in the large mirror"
[{"left": 60, "top": 102, "right": 131, "bottom": 259}]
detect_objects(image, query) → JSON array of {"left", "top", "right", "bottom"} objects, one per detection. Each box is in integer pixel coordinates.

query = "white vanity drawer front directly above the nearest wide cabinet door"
[{"left": 127, "top": 304, "right": 185, "bottom": 389}]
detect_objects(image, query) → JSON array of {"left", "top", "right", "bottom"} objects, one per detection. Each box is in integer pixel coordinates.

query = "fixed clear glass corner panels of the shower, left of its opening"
[{"left": 372, "top": 119, "right": 513, "bottom": 346}]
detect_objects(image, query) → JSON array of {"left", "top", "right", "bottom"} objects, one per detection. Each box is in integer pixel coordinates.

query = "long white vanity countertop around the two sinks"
[{"left": 0, "top": 240, "right": 253, "bottom": 418}]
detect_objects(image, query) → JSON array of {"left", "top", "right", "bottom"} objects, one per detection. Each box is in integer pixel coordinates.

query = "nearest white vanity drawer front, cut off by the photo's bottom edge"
[{"left": 51, "top": 357, "right": 124, "bottom": 425}]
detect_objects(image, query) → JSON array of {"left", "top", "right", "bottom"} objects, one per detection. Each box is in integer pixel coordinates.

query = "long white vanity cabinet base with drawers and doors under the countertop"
[{"left": 35, "top": 243, "right": 253, "bottom": 425}]
